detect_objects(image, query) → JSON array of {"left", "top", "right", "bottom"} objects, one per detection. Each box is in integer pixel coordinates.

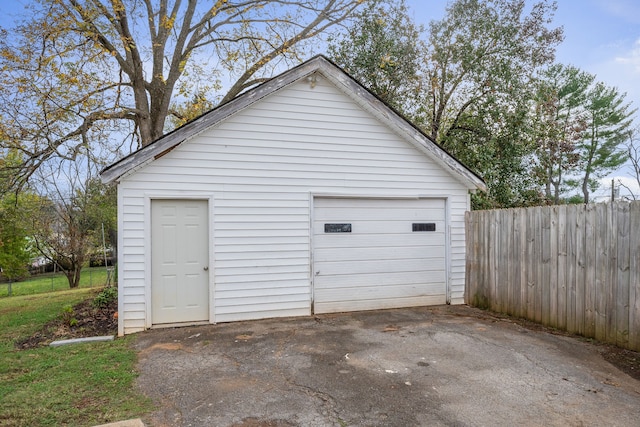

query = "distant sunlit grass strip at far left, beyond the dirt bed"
[{"left": 0, "top": 267, "right": 112, "bottom": 298}]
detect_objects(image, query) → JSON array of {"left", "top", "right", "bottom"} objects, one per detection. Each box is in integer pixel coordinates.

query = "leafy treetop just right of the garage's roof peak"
[{"left": 328, "top": 0, "right": 425, "bottom": 116}]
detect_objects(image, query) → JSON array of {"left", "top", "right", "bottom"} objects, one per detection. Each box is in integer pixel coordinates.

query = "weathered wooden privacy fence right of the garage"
[{"left": 465, "top": 202, "right": 640, "bottom": 351}]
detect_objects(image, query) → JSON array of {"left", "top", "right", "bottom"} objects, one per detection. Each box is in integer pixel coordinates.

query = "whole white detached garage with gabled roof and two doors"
[{"left": 102, "top": 56, "right": 485, "bottom": 335}]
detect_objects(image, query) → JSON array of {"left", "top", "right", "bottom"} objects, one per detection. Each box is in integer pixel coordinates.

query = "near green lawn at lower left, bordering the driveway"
[{"left": 0, "top": 289, "right": 152, "bottom": 426}]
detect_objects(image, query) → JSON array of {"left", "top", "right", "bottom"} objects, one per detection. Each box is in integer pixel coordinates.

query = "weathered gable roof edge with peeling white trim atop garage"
[{"left": 100, "top": 55, "right": 487, "bottom": 191}]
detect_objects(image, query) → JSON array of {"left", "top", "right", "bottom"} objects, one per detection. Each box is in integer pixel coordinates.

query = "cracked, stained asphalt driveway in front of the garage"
[{"left": 136, "top": 306, "right": 640, "bottom": 427}]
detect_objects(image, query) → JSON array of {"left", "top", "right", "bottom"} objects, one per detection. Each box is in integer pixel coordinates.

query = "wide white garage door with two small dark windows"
[{"left": 313, "top": 198, "right": 446, "bottom": 313}]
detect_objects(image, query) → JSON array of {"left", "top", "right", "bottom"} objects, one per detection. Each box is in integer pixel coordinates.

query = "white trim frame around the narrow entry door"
[{"left": 144, "top": 192, "right": 215, "bottom": 329}]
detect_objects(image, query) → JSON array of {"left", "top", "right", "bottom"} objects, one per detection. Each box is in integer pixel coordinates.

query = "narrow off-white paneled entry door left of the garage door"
[{"left": 151, "top": 200, "right": 209, "bottom": 325}]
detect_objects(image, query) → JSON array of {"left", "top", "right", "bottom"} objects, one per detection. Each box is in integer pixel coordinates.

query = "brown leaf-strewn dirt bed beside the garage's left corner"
[{"left": 15, "top": 295, "right": 118, "bottom": 350}]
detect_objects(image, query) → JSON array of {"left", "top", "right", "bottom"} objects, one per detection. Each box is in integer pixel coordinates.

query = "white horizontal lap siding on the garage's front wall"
[{"left": 119, "top": 74, "right": 468, "bottom": 333}]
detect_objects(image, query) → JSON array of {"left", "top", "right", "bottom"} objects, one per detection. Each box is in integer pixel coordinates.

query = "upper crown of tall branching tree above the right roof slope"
[{"left": 426, "top": 0, "right": 563, "bottom": 146}]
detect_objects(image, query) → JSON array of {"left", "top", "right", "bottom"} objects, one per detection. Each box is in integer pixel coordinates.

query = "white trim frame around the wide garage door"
[{"left": 309, "top": 191, "right": 451, "bottom": 314}]
